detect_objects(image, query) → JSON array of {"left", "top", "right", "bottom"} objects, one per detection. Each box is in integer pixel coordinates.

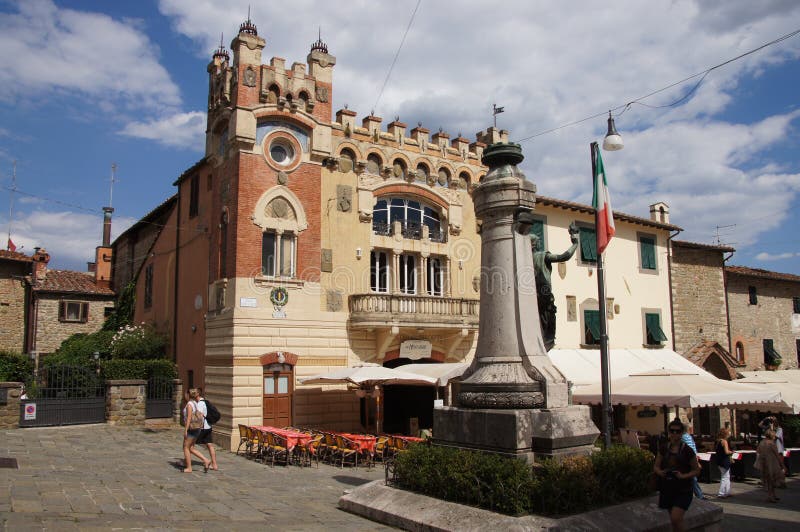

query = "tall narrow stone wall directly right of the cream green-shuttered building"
[{"left": 671, "top": 244, "right": 728, "bottom": 355}]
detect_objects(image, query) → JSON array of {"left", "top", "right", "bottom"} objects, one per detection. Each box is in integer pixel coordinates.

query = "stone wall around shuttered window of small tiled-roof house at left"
[{"left": 35, "top": 294, "right": 114, "bottom": 353}]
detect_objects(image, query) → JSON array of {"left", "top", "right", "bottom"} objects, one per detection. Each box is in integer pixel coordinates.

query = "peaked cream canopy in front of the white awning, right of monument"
[{"left": 572, "top": 366, "right": 781, "bottom": 408}]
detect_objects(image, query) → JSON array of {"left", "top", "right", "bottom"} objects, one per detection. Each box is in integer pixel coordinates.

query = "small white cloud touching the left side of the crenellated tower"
[{"left": 120, "top": 111, "right": 206, "bottom": 151}]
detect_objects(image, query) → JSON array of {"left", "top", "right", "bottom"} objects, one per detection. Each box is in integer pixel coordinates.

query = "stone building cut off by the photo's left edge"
[{"left": 0, "top": 250, "right": 33, "bottom": 353}]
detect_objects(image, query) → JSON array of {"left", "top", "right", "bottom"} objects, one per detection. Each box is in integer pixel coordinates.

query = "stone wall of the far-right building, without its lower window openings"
[{"left": 727, "top": 270, "right": 800, "bottom": 370}]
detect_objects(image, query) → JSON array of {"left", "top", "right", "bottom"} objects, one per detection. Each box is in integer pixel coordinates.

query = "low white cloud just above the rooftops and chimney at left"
[{"left": 2, "top": 210, "right": 136, "bottom": 271}]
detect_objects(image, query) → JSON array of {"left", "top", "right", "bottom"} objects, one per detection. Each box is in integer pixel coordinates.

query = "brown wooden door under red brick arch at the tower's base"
[{"left": 261, "top": 351, "right": 297, "bottom": 427}]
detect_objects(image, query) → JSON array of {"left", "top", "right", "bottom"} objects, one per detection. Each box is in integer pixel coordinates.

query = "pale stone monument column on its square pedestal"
[{"left": 433, "top": 143, "right": 599, "bottom": 461}]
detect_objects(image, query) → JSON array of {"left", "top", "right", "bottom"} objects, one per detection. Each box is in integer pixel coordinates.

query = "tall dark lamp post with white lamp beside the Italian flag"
[{"left": 589, "top": 111, "right": 625, "bottom": 449}]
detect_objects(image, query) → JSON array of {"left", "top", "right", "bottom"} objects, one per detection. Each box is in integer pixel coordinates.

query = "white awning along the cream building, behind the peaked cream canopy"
[{"left": 548, "top": 349, "right": 716, "bottom": 385}]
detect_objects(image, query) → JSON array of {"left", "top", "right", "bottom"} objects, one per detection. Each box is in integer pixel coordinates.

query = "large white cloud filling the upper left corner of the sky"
[{"left": 0, "top": 0, "right": 181, "bottom": 109}]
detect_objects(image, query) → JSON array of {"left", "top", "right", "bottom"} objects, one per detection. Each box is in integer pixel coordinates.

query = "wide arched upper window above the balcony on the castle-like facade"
[{"left": 372, "top": 197, "right": 446, "bottom": 242}]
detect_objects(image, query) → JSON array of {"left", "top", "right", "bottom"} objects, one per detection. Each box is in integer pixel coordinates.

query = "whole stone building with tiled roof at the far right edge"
[{"left": 725, "top": 266, "right": 800, "bottom": 370}]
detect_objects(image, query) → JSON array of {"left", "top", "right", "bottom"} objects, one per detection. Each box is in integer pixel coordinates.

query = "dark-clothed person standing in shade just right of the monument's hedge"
[{"left": 653, "top": 419, "right": 700, "bottom": 532}]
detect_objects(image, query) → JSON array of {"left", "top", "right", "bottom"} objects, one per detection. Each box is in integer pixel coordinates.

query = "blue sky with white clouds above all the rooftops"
[{"left": 0, "top": 0, "right": 800, "bottom": 275}]
